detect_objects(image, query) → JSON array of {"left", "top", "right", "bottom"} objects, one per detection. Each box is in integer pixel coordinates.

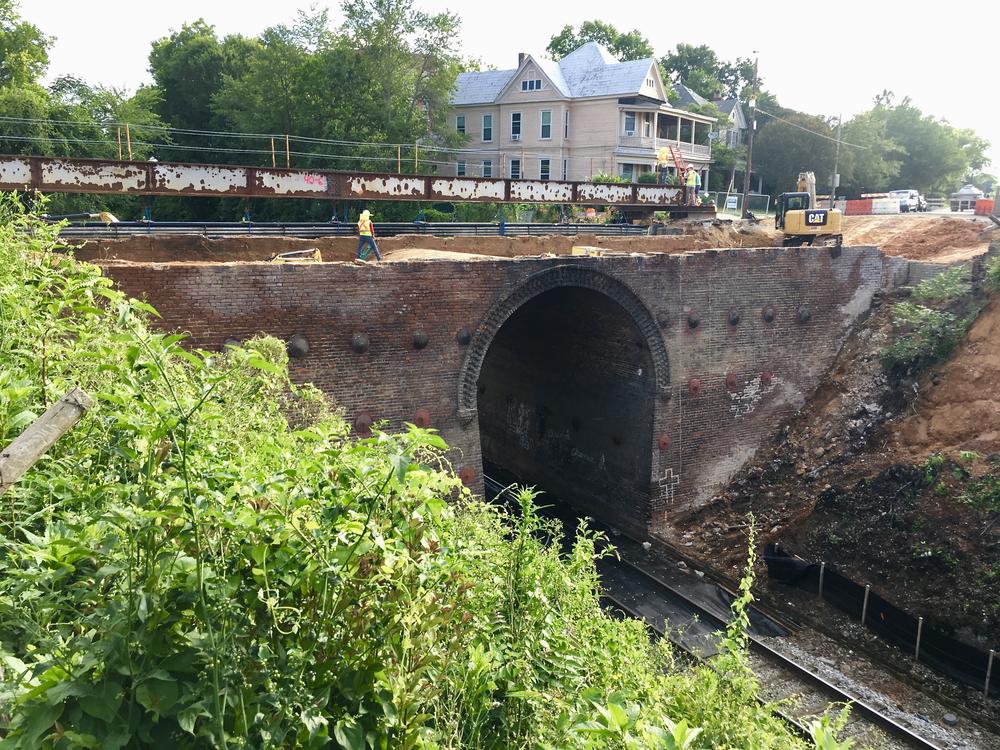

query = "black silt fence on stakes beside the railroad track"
[{"left": 764, "top": 544, "right": 1000, "bottom": 696}]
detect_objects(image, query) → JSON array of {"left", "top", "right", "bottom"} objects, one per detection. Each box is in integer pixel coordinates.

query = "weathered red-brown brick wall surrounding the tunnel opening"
[{"left": 105, "top": 247, "right": 883, "bottom": 533}]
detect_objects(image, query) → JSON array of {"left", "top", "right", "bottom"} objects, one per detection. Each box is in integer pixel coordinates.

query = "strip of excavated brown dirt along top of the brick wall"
[{"left": 76, "top": 224, "right": 775, "bottom": 263}]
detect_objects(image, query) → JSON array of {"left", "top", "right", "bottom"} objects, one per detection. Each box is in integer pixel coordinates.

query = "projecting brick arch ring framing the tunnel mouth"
[{"left": 458, "top": 265, "right": 670, "bottom": 426}]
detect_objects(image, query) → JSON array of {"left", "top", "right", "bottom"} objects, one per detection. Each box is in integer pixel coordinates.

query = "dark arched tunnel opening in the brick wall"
[{"left": 478, "top": 287, "right": 656, "bottom": 530}]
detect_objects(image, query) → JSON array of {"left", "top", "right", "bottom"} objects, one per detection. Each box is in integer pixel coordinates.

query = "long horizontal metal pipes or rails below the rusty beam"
[{"left": 52, "top": 221, "right": 649, "bottom": 239}]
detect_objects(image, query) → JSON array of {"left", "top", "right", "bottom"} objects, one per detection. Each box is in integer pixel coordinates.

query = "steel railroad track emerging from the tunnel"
[{"left": 484, "top": 477, "right": 941, "bottom": 750}]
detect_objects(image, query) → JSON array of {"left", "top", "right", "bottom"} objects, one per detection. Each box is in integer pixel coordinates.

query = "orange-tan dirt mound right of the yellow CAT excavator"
[{"left": 844, "top": 214, "right": 993, "bottom": 261}]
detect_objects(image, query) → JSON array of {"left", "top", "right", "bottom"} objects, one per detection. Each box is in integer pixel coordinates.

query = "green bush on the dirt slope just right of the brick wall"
[{"left": 882, "top": 302, "right": 971, "bottom": 373}]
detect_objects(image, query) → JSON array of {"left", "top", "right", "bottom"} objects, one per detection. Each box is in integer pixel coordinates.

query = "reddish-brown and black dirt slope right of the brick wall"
[{"left": 678, "top": 276, "right": 1000, "bottom": 646}]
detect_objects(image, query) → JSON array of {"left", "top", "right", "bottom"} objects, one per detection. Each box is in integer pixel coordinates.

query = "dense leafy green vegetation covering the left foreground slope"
[{"left": 0, "top": 199, "right": 830, "bottom": 750}]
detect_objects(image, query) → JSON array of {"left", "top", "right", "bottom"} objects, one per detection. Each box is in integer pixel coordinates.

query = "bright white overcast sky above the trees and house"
[{"left": 21, "top": 0, "right": 1000, "bottom": 172}]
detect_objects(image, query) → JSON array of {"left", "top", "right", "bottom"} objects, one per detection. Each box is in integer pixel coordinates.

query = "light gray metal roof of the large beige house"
[{"left": 452, "top": 42, "right": 654, "bottom": 105}]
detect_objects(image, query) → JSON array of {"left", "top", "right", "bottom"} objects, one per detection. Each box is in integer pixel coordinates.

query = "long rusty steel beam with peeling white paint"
[{"left": 0, "top": 155, "right": 685, "bottom": 208}]
